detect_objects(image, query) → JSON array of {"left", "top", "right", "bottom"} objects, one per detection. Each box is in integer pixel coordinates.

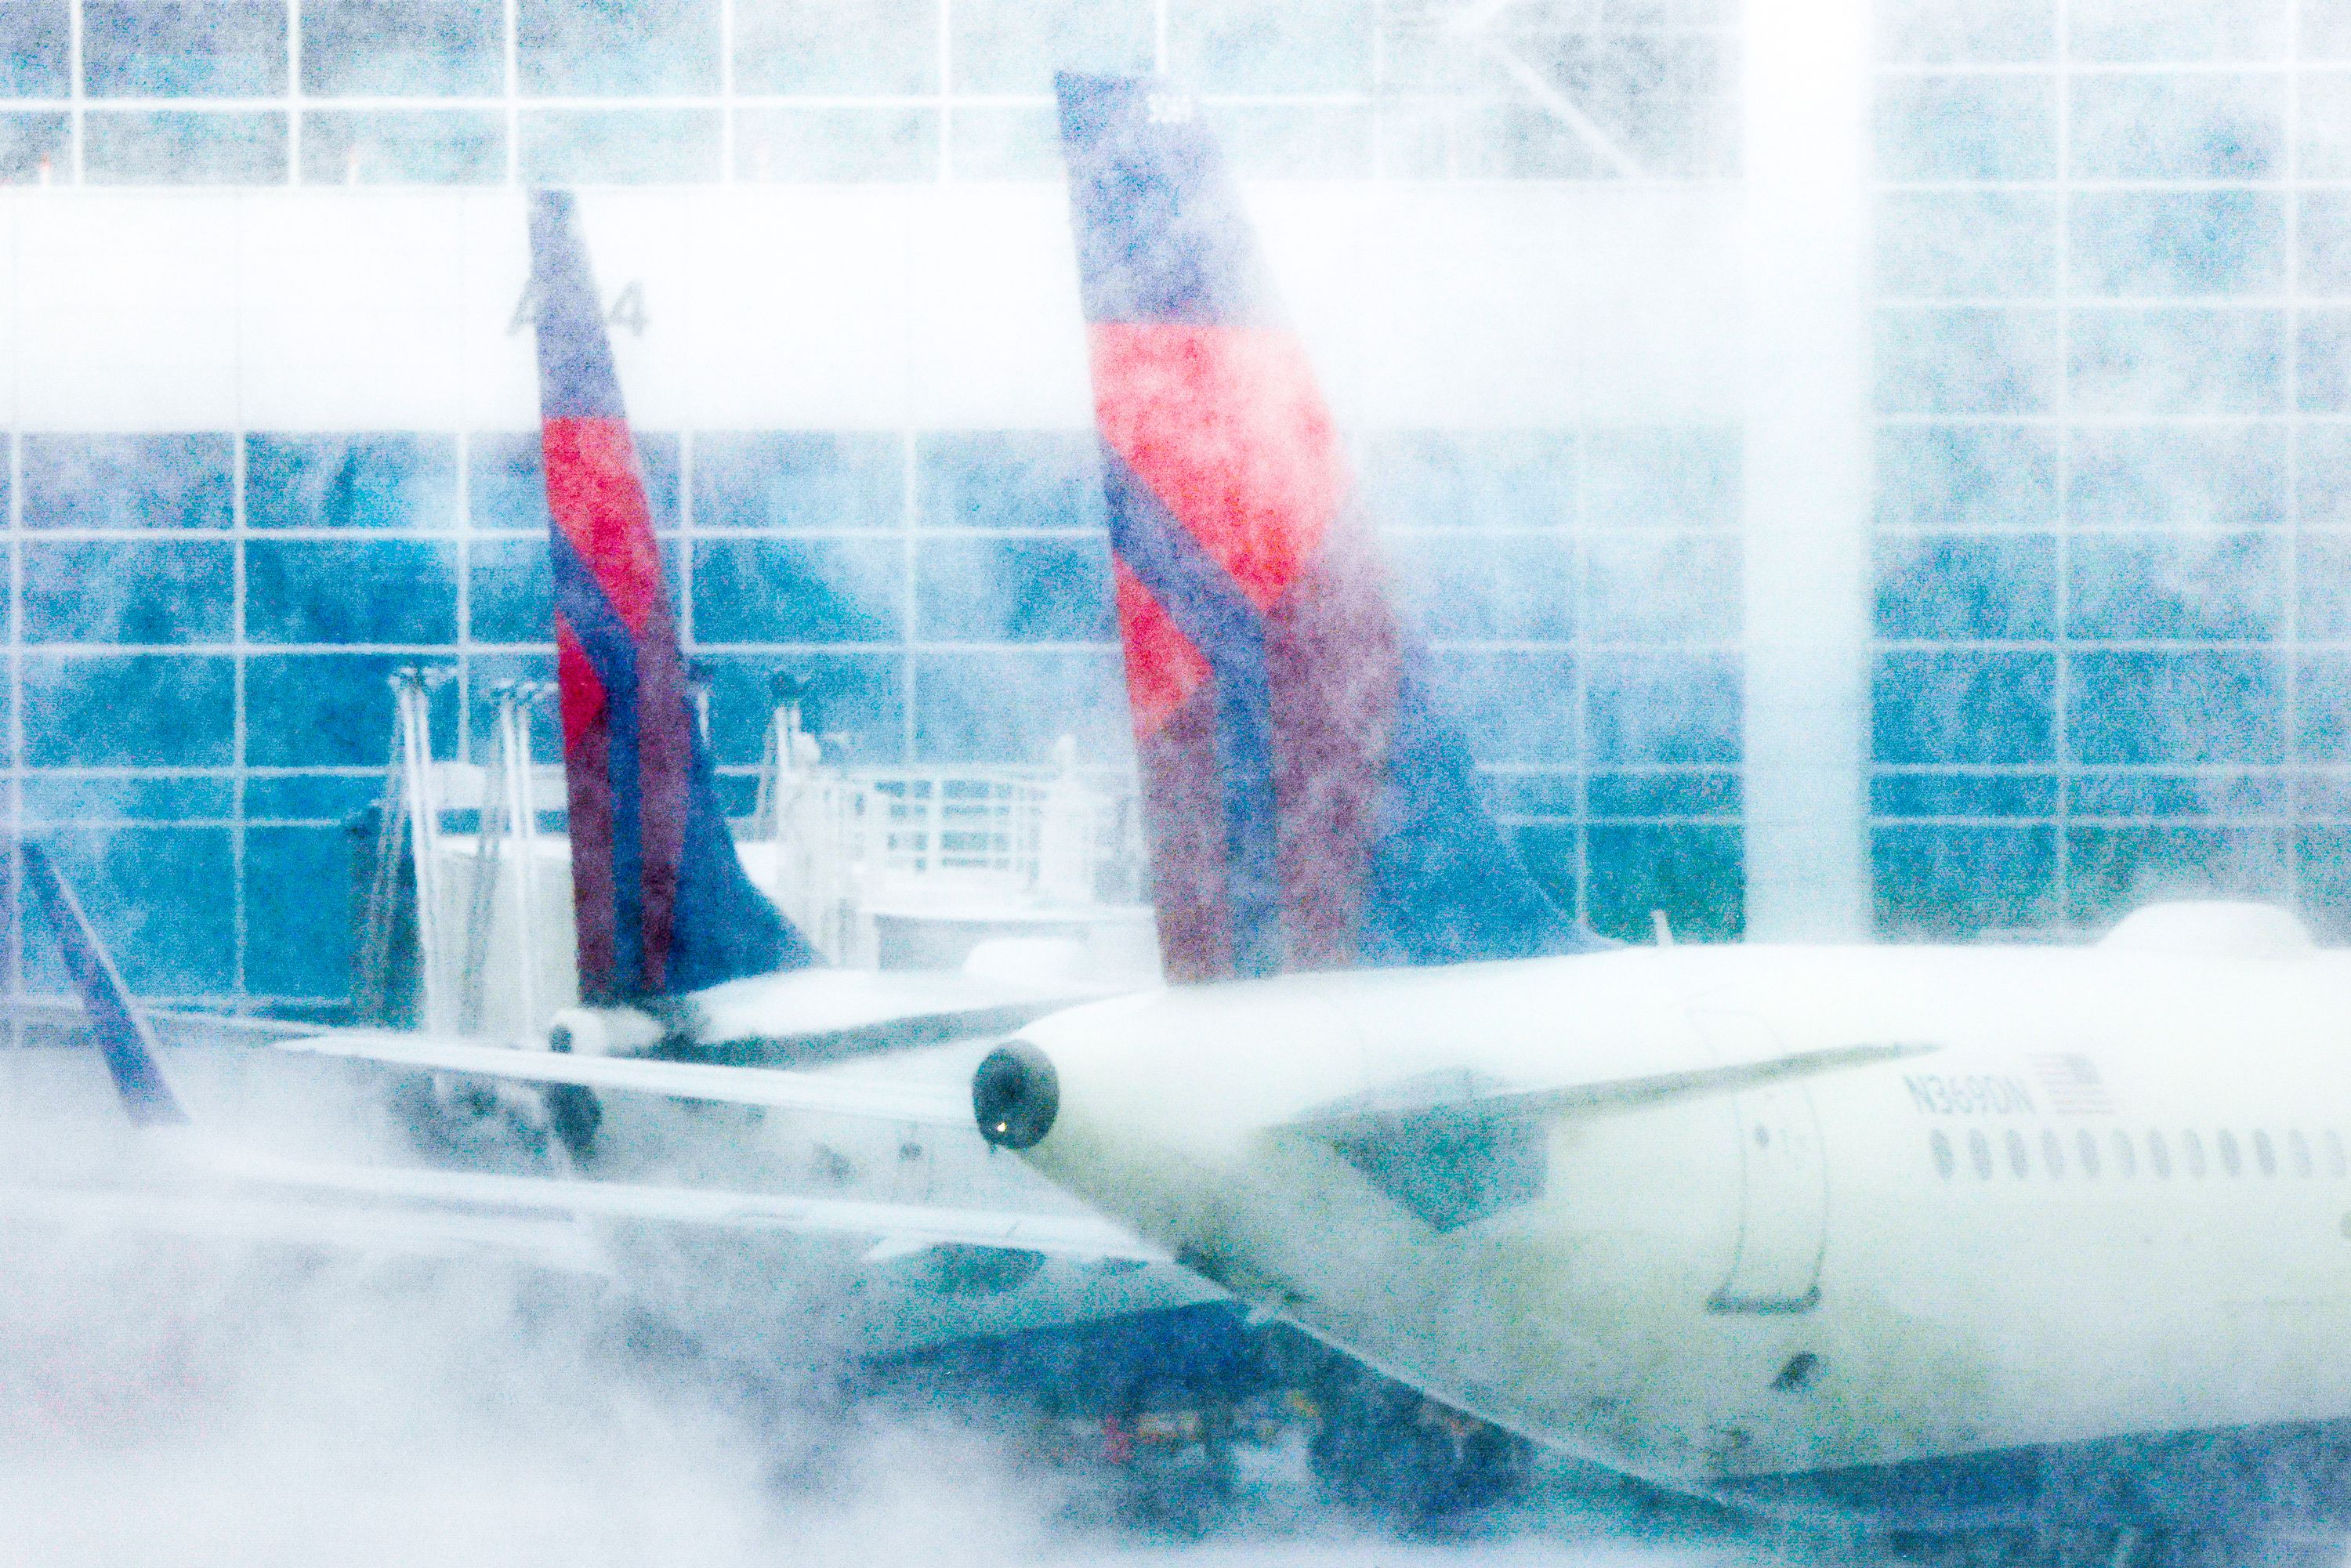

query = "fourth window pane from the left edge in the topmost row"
[{"left": 515, "top": 0, "right": 719, "bottom": 96}]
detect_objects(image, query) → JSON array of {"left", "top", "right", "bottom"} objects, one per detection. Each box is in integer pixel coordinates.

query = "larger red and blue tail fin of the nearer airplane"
[{"left": 1056, "top": 75, "right": 1599, "bottom": 980}]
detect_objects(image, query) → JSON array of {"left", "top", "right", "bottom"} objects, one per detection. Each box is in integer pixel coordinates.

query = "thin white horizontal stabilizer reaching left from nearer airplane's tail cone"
[{"left": 273, "top": 1030, "right": 971, "bottom": 1126}]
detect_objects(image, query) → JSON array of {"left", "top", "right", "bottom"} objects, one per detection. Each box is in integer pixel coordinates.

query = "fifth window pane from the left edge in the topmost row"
[{"left": 736, "top": 0, "right": 940, "bottom": 94}]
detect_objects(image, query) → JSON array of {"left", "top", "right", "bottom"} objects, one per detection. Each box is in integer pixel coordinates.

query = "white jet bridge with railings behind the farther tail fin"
[{"left": 353, "top": 670, "right": 1157, "bottom": 1039}]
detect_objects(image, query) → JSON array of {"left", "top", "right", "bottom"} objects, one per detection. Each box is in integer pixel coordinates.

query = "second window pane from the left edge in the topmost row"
[{"left": 82, "top": 0, "right": 287, "bottom": 99}]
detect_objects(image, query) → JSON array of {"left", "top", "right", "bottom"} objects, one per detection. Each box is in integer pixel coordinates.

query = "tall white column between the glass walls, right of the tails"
[{"left": 1744, "top": 0, "right": 1869, "bottom": 940}]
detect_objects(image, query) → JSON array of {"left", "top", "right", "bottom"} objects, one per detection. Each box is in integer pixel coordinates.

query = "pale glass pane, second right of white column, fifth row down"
[{"left": 2067, "top": 425, "right": 2285, "bottom": 527}]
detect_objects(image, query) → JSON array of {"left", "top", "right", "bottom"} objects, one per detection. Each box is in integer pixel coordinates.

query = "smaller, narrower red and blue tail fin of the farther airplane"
[{"left": 531, "top": 190, "right": 818, "bottom": 1004}]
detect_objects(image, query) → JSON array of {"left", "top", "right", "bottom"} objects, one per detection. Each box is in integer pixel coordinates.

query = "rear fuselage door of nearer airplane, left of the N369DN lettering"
[{"left": 1690, "top": 1013, "right": 1829, "bottom": 1312}]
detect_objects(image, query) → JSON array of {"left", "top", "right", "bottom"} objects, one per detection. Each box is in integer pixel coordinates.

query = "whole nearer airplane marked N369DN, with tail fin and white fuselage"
[{"left": 940, "top": 75, "right": 2351, "bottom": 1566}]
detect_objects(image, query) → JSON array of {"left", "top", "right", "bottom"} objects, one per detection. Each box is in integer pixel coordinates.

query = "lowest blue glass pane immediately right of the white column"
[{"left": 1869, "top": 827, "right": 2057, "bottom": 940}]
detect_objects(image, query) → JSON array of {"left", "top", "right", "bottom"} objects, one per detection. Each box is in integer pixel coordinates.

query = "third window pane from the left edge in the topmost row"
[{"left": 301, "top": 0, "right": 505, "bottom": 96}]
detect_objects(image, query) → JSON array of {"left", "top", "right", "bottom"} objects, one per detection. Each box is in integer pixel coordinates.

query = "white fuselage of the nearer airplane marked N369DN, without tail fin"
[{"left": 1023, "top": 907, "right": 2351, "bottom": 1523}]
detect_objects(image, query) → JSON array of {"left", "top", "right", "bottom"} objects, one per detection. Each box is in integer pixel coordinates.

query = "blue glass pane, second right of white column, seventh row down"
[{"left": 2067, "top": 651, "right": 2285, "bottom": 762}]
